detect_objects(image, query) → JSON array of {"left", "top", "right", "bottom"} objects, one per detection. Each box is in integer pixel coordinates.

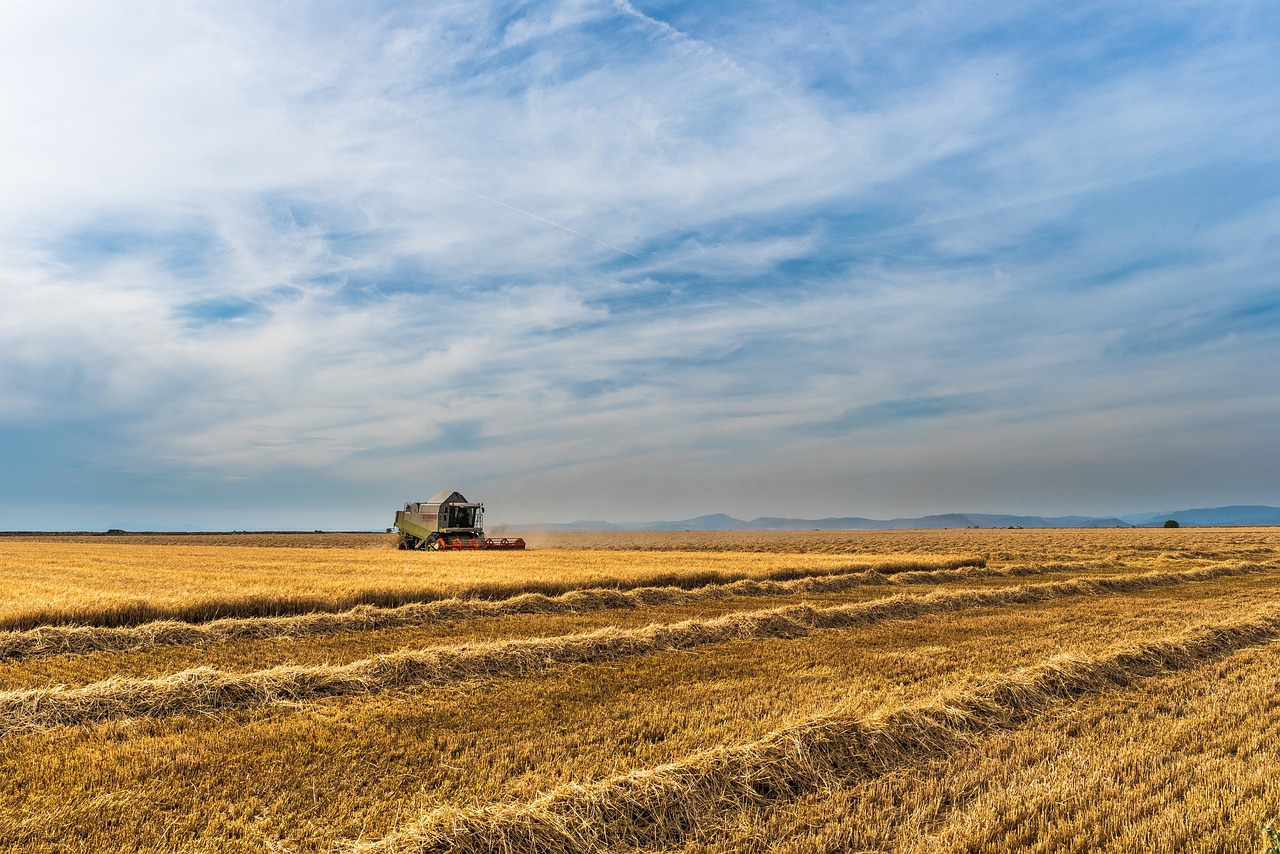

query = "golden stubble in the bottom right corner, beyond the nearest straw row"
[{"left": 711, "top": 643, "right": 1280, "bottom": 854}]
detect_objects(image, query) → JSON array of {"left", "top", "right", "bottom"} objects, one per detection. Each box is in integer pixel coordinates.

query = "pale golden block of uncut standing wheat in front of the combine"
[{"left": 0, "top": 542, "right": 984, "bottom": 630}]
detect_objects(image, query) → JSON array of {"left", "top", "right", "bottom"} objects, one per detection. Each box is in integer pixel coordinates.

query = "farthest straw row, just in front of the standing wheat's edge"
[{"left": 0, "top": 558, "right": 1084, "bottom": 661}]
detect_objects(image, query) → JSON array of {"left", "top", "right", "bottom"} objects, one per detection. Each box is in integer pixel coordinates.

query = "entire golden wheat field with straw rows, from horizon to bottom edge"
[{"left": 0, "top": 529, "right": 1280, "bottom": 854}]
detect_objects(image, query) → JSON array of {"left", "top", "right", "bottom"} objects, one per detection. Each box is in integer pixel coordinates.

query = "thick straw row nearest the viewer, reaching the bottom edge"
[{"left": 351, "top": 608, "right": 1280, "bottom": 854}]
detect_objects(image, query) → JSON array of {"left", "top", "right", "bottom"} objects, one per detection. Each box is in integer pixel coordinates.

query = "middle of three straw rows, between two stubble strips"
[{"left": 0, "top": 565, "right": 1275, "bottom": 735}]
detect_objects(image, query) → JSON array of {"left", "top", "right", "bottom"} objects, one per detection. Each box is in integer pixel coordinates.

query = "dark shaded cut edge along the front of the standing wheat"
[{"left": 0, "top": 554, "right": 988, "bottom": 631}]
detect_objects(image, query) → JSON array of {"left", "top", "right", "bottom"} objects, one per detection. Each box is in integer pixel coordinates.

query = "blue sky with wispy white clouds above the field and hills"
[{"left": 0, "top": 0, "right": 1280, "bottom": 530}]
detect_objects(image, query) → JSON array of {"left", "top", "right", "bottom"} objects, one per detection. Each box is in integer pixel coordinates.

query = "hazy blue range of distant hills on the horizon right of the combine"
[{"left": 507, "top": 504, "right": 1280, "bottom": 531}]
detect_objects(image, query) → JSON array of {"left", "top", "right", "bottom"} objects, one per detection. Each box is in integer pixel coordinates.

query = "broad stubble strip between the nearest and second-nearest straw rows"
[{"left": 0, "top": 591, "right": 1218, "bottom": 854}]
